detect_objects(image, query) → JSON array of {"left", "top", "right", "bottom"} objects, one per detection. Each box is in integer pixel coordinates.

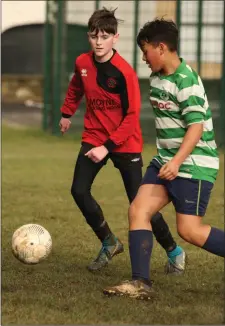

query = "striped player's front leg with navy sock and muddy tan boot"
[{"left": 103, "top": 165, "right": 170, "bottom": 299}]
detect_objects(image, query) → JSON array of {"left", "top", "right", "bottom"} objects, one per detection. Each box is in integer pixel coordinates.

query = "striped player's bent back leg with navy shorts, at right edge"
[{"left": 169, "top": 178, "right": 225, "bottom": 257}]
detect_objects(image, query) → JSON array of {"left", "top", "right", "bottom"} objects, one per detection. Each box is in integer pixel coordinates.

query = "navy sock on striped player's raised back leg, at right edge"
[{"left": 202, "top": 228, "right": 225, "bottom": 257}]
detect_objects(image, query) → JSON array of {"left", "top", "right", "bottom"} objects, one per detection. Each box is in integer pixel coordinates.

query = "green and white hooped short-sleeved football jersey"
[{"left": 150, "top": 59, "right": 219, "bottom": 182}]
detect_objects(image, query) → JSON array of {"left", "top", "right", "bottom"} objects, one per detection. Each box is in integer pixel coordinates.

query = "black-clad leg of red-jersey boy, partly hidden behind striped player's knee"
[{"left": 115, "top": 154, "right": 186, "bottom": 274}]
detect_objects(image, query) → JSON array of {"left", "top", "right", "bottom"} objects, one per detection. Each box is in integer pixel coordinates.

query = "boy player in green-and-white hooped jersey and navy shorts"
[{"left": 104, "top": 19, "right": 225, "bottom": 299}]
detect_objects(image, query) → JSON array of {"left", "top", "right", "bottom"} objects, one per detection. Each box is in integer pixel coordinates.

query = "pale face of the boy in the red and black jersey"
[{"left": 88, "top": 31, "right": 119, "bottom": 57}]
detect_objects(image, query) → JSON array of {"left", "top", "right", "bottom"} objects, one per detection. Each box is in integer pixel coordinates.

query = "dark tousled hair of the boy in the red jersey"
[{"left": 88, "top": 7, "right": 122, "bottom": 35}]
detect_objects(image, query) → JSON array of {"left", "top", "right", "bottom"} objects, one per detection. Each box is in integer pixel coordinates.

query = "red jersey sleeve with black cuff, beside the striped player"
[{"left": 104, "top": 73, "right": 141, "bottom": 151}]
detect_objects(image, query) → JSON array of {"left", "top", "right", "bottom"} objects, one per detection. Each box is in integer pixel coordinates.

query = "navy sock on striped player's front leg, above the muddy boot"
[{"left": 129, "top": 230, "right": 153, "bottom": 282}]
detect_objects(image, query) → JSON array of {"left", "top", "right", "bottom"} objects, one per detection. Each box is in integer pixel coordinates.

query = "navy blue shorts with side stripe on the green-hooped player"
[{"left": 141, "top": 162, "right": 213, "bottom": 216}]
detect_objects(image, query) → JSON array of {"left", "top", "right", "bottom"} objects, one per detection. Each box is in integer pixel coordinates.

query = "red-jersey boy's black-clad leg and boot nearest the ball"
[{"left": 71, "top": 144, "right": 123, "bottom": 271}]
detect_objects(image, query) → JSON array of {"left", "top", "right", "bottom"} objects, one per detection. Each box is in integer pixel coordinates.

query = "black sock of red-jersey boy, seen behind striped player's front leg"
[{"left": 151, "top": 212, "right": 177, "bottom": 252}]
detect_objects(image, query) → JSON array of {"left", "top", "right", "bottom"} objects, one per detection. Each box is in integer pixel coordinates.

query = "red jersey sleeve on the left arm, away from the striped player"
[{"left": 61, "top": 64, "right": 84, "bottom": 118}]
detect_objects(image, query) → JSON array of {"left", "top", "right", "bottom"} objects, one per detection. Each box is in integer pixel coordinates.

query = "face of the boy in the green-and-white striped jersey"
[{"left": 141, "top": 42, "right": 165, "bottom": 72}]
